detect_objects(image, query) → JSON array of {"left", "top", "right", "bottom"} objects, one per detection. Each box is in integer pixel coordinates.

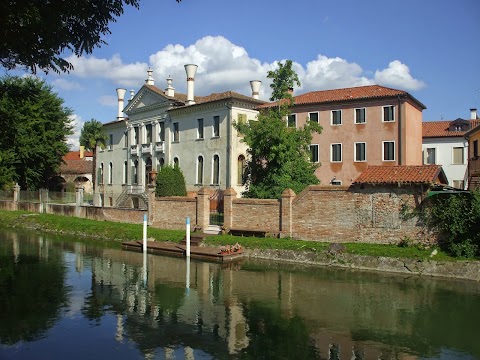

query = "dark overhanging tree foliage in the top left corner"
[{"left": 0, "top": 0, "right": 180, "bottom": 74}]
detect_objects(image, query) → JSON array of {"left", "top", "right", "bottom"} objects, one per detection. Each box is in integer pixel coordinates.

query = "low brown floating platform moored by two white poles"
[{"left": 122, "top": 241, "right": 243, "bottom": 262}]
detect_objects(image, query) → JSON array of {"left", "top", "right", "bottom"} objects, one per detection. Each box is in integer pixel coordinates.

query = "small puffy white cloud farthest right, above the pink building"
[{"left": 375, "top": 60, "right": 425, "bottom": 90}]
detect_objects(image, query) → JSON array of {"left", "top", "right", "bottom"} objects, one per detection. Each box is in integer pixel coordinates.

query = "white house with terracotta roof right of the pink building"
[{"left": 422, "top": 109, "right": 480, "bottom": 189}]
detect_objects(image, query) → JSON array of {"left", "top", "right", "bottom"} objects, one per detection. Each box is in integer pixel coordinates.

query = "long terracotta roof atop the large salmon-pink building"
[{"left": 260, "top": 85, "right": 426, "bottom": 109}]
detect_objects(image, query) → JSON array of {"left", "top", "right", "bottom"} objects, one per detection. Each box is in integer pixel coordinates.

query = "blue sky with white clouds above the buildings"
[{"left": 1, "top": 0, "right": 480, "bottom": 150}]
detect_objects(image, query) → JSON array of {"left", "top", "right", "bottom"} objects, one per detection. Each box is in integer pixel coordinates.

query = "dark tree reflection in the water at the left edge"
[{"left": 0, "top": 249, "right": 67, "bottom": 345}]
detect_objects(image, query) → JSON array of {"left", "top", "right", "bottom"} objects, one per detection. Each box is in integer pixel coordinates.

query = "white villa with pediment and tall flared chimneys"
[{"left": 96, "top": 65, "right": 264, "bottom": 206}]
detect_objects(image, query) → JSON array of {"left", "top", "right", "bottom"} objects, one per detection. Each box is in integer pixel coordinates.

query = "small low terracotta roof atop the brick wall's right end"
[{"left": 353, "top": 165, "right": 447, "bottom": 184}]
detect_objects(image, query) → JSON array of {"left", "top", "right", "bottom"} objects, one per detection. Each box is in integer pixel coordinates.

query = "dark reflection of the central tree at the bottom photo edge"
[{"left": 239, "top": 302, "right": 320, "bottom": 359}]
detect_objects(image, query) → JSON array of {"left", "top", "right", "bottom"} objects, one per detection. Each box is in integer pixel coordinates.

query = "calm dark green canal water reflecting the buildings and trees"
[{"left": 0, "top": 229, "right": 480, "bottom": 360}]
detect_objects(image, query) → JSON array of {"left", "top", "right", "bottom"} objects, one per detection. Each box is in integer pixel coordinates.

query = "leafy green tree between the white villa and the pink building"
[{"left": 235, "top": 60, "right": 321, "bottom": 199}]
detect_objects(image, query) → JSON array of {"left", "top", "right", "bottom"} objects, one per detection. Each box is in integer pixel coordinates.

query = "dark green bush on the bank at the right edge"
[{"left": 423, "top": 189, "right": 480, "bottom": 258}]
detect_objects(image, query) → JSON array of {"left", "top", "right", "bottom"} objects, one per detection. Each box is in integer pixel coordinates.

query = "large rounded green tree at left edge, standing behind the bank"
[{"left": 0, "top": 76, "right": 72, "bottom": 189}]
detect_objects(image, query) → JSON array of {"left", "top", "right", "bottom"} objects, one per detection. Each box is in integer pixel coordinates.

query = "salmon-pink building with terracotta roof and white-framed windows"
[{"left": 261, "top": 85, "right": 425, "bottom": 186}]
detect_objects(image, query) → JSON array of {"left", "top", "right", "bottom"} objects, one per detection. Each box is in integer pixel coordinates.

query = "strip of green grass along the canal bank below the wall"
[{"left": 0, "top": 211, "right": 457, "bottom": 261}]
